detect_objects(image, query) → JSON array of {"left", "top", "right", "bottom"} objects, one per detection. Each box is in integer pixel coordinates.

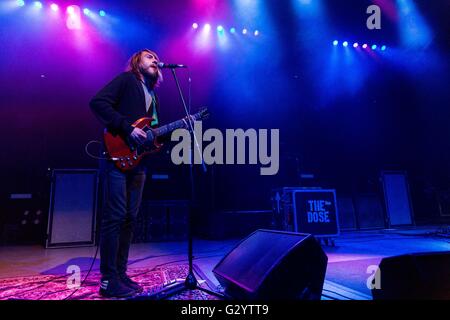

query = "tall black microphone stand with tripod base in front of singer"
[{"left": 134, "top": 67, "right": 225, "bottom": 300}]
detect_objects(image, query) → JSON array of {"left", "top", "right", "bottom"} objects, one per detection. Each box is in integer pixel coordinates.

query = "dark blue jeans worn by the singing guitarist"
[{"left": 100, "top": 161, "right": 146, "bottom": 279}]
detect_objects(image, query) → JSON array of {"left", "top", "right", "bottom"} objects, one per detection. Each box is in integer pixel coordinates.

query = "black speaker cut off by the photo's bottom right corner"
[{"left": 372, "top": 251, "right": 450, "bottom": 300}]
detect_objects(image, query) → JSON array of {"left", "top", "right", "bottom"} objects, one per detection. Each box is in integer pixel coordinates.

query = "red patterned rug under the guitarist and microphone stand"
[{"left": 0, "top": 265, "right": 217, "bottom": 300}]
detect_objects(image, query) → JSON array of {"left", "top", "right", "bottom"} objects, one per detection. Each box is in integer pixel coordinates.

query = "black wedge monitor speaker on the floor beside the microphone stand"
[{"left": 213, "top": 229, "right": 328, "bottom": 300}]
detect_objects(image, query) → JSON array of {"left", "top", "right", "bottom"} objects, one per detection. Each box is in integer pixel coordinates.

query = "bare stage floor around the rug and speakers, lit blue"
[{"left": 0, "top": 226, "right": 450, "bottom": 300}]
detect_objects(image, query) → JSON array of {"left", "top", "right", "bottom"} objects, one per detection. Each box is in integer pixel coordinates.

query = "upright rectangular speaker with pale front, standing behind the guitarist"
[{"left": 46, "top": 169, "right": 98, "bottom": 248}]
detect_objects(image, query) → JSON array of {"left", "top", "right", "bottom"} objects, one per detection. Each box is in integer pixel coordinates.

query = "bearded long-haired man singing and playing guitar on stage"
[{"left": 89, "top": 49, "right": 162, "bottom": 297}]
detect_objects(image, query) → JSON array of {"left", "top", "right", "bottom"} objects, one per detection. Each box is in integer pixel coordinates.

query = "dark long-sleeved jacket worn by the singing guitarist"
[{"left": 89, "top": 72, "right": 160, "bottom": 136}]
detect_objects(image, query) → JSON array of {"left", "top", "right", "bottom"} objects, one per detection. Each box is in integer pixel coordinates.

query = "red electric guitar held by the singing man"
[{"left": 104, "top": 108, "right": 209, "bottom": 172}]
